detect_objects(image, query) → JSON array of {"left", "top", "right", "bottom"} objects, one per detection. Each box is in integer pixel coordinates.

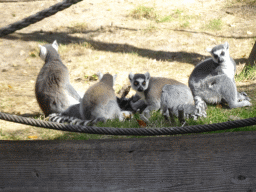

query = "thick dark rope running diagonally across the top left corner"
[{"left": 0, "top": 0, "right": 82, "bottom": 37}]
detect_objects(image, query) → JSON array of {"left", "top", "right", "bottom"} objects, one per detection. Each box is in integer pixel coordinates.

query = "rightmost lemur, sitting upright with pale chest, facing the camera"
[{"left": 188, "top": 42, "right": 252, "bottom": 108}]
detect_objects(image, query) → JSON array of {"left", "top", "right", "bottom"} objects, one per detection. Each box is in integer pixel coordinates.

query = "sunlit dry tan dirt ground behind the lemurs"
[{"left": 0, "top": 0, "right": 256, "bottom": 139}]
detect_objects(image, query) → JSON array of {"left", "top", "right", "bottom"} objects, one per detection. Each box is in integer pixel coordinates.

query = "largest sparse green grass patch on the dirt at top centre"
[{"left": 129, "top": 5, "right": 157, "bottom": 19}]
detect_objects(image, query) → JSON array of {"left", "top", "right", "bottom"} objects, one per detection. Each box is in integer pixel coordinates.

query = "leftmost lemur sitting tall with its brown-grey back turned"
[{"left": 35, "top": 40, "right": 81, "bottom": 116}]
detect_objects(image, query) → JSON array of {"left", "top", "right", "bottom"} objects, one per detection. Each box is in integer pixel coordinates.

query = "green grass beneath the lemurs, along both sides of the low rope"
[{"left": 49, "top": 100, "right": 256, "bottom": 140}]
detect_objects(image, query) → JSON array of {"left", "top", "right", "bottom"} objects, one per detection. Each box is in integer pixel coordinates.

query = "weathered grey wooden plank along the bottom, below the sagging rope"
[{"left": 0, "top": 132, "right": 256, "bottom": 192}]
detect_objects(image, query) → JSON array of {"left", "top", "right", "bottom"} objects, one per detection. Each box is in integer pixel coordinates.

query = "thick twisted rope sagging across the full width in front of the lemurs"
[{"left": 0, "top": 112, "right": 256, "bottom": 136}]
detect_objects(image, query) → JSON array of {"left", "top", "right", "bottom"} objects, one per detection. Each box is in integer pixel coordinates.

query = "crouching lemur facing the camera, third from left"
[{"left": 129, "top": 72, "right": 205, "bottom": 122}]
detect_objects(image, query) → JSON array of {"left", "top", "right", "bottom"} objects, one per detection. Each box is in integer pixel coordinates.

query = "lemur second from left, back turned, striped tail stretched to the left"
[{"left": 49, "top": 73, "right": 131, "bottom": 125}]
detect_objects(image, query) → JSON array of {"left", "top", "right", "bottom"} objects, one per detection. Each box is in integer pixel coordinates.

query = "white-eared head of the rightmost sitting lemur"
[{"left": 207, "top": 42, "right": 229, "bottom": 64}]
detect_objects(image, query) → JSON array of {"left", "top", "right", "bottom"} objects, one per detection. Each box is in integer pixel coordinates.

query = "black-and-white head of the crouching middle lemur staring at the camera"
[{"left": 129, "top": 72, "right": 150, "bottom": 92}]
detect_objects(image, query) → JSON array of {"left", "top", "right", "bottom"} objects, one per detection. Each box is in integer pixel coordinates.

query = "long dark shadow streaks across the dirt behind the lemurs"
[{"left": 2, "top": 26, "right": 253, "bottom": 65}]
